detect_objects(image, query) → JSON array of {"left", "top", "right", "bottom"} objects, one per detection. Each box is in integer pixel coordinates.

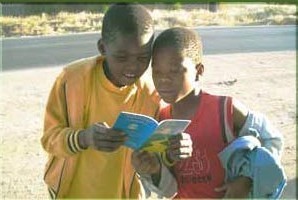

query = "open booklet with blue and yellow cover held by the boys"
[{"left": 113, "top": 112, "right": 190, "bottom": 152}]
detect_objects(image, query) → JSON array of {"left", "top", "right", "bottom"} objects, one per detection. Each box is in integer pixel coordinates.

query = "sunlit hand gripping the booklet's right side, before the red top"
[{"left": 166, "top": 133, "right": 192, "bottom": 162}]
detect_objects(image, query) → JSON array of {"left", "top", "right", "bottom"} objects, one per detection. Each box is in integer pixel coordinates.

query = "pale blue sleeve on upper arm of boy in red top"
[{"left": 239, "top": 112, "right": 283, "bottom": 159}]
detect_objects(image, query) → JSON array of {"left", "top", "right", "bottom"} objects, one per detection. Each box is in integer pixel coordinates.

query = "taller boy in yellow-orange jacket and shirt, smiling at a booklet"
[{"left": 41, "top": 4, "right": 159, "bottom": 199}]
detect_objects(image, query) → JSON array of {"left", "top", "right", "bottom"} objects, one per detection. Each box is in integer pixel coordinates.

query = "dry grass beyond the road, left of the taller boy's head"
[{"left": 0, "top": 12, "right": 103, "bottom": 37}]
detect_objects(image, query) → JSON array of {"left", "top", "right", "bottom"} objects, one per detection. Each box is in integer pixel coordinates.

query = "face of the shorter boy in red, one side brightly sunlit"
[{"left": 152, "top": 47, "right": 196, "bottom": 103}]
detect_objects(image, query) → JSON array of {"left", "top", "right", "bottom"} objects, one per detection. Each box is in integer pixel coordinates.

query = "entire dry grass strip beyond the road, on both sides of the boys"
[{"left": 0, "top": 4, "right": 296, "bottom": 37}]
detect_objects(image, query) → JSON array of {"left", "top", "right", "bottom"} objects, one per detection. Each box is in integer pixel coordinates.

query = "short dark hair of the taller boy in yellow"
[{"left": 101, "top": 3, "right": 154, "bottom": 42}]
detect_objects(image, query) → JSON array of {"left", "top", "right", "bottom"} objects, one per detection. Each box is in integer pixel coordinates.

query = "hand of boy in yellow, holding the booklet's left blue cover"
[{"left": 79, "top": 123, "right": 127, "bottom": 152}]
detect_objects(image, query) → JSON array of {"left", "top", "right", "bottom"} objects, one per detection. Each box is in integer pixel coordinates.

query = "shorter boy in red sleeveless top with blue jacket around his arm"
[{"left": 132, "top": 28, "right": 283, "bottom": 198}]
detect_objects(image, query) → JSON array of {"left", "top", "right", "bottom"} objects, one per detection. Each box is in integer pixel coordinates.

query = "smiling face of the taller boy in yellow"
[{"left": 103, "top": 32, "right": 153, "bottom": 87}]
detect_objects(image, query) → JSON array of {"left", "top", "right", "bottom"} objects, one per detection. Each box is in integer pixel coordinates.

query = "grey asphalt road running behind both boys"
[{"left": 0, "top": 25, "right": 296, "bottom": 71}]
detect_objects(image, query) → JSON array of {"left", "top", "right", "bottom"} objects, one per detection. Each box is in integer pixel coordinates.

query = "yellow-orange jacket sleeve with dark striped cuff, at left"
[{"left": 41, "top": 71, "right": 82, "bottom": 157}]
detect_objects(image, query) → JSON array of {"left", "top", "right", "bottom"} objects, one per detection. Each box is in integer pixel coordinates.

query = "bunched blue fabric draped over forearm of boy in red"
[{"left": 218, "top": 136, "right": 286, "bottom": 199}]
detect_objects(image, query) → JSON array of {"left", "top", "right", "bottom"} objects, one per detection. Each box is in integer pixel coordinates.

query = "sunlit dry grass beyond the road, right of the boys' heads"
[{"left": 153, "top": 4, "right": 296, "bottom": 28}]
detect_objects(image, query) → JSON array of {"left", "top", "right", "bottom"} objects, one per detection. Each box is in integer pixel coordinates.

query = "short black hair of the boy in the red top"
[{"left": 153, "top": 27, "right": 203, "bottom": 64}]
